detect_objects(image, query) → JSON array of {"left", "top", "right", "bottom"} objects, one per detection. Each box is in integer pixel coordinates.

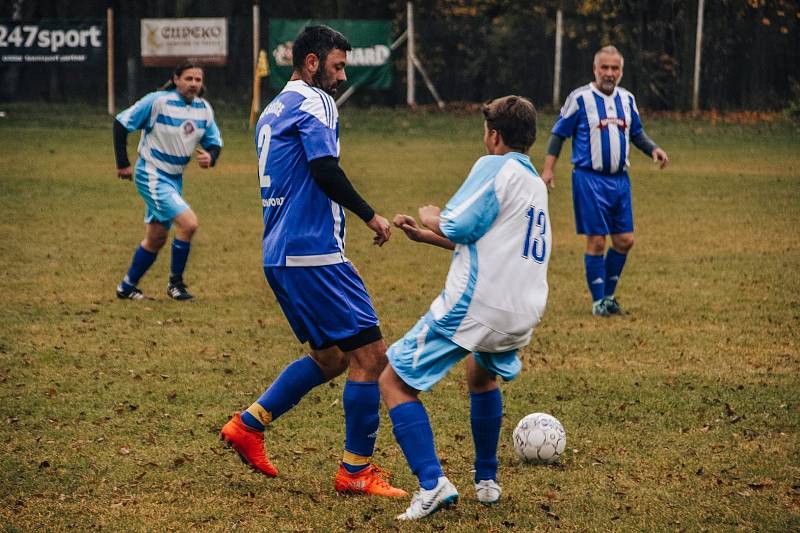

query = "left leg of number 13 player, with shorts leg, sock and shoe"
[{"left": 380, "top": 318, "right": 468, "bottom": 520}]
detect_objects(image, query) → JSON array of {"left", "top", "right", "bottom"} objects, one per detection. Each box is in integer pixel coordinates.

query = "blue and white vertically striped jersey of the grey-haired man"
[{"left": 552, "top": 83, "right": 643, "bottom": 174}]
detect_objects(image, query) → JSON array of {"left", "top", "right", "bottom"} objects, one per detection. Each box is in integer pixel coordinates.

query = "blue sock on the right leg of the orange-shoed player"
[{"left": 342, "top": 381, "right": 381, "bottom": 473}]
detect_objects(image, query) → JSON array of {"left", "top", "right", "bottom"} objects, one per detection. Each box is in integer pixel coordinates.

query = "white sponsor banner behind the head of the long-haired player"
[{"left": 141, "top": 18, "right": 228, "bottom": 67}]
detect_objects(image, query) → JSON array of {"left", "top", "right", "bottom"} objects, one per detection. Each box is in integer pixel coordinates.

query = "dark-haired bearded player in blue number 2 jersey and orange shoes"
[{"left": 222, "top": 26, "right": 406, "bottom": 497}]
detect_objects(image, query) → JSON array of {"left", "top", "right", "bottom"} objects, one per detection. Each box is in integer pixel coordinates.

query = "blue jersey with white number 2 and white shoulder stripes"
[{"left": 256, "top": 80, "right": 347, "bottom": 267}]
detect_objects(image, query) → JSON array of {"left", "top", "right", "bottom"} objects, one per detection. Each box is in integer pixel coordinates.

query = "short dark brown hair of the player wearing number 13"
[{"left": 481, "top": 94, "right": 536, "bottom": 152}]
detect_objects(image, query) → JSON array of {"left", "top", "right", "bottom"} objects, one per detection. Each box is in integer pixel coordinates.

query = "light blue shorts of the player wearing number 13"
[{"left": 386, "top": 317, "right": 522, "bottom": 391}]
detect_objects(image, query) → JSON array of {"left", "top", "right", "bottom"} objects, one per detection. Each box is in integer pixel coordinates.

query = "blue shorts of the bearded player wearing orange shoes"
[{"left": 264, "top": 263, "right": 378, "bottom": 349}]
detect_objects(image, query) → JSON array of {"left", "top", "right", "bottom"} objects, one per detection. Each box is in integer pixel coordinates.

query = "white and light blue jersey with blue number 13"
[{"left": 425, "top": 152, "right": 552, "bottom": 353}]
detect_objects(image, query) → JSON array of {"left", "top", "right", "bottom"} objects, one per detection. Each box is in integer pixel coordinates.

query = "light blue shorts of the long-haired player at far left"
[{"left": 134, "top": 158, "right": 189, "bottom": 229}]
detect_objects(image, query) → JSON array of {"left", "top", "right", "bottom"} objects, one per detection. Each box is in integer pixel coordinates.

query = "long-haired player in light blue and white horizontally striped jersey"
[{"left": 114, "top": 61, "right": 222, "bottom": 300}]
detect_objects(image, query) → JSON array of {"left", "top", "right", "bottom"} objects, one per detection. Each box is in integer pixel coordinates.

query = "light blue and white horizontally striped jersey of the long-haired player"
[{"left": 116, "top": 90, "right": 222, "bottom": 177}]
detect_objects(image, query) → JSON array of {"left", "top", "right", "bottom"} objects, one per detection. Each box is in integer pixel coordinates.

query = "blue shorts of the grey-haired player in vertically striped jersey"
[{"left": 572, "top": 168, "right": 633, "bottom": 235}]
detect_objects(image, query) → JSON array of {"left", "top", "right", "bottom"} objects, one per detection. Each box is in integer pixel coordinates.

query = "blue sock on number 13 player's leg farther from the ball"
[{"left": 389, "top": 401, "right": 444, "bottom": 490}]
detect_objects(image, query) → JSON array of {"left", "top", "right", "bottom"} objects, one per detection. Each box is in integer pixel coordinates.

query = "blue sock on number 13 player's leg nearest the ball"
[{"left": 469, "top": 388, "right": 503, "bottom": 483}]
